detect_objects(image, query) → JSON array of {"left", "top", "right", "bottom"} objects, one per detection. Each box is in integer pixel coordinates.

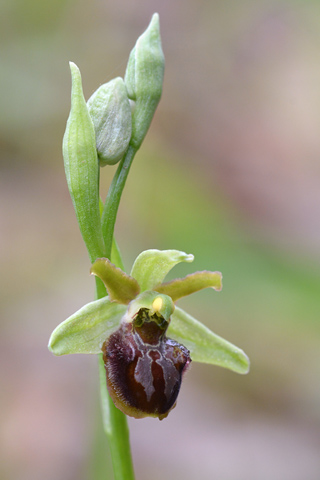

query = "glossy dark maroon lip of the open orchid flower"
[{"left": 102, "top": 308, "right": 191, "bottom": 420}]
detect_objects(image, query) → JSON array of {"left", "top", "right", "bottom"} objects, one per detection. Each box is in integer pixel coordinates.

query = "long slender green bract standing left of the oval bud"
[{"left": 63, "top": 62, "right": 104, "bottom": 262}]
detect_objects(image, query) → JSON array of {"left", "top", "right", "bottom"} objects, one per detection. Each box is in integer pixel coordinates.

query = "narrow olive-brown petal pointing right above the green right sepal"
[{"left": 153, "top": 271, "right": 222, "bottom": 302}]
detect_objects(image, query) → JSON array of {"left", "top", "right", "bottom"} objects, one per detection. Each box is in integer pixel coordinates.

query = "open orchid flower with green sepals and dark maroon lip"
[{"left": 49, "top": 250, "right": 249, "bottom": 420}]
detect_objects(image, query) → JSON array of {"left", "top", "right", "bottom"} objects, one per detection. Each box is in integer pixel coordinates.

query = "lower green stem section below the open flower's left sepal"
[{"left": 99, "top": 354, "right": 134, "bottom": 480}]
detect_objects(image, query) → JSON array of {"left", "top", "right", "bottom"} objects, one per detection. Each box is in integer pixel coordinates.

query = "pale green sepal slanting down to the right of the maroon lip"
[{"left": 167, "top": 307, "right": 250, "bottom": 374}]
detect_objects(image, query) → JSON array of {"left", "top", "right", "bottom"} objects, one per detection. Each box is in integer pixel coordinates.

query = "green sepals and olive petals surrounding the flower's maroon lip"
[{"left": 49, "top": 250, "right": 249, "bottom": 373}]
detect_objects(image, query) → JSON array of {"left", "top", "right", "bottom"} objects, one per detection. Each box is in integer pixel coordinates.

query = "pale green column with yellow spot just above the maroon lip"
[{"left": 123, "top": 290, "right": 175, "bottom": 323}]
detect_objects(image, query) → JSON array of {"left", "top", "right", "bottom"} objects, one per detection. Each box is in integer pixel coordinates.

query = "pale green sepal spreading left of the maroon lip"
[{"left": 48, "top": 297, "right": 126, "bottom": 355}]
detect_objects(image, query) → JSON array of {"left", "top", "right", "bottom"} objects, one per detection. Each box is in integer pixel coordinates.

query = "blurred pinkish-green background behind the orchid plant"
[{"left": 0, "top": 0, "right": 320, "bottom": 480}]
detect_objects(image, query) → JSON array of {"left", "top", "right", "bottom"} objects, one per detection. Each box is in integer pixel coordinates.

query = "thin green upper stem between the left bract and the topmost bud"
[{"left": 102, "top": 145, "right": 137, "bottom": 259}]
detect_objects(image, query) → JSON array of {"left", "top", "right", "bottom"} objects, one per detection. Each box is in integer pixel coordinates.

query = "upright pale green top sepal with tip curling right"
[{"left": 130, "top": 250, "right": 194, "bottom": 292}]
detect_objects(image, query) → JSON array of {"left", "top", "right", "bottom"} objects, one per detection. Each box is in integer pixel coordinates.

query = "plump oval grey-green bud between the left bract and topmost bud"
[{"left": 87, "top": 77, "right": 132, "bottom": 167}]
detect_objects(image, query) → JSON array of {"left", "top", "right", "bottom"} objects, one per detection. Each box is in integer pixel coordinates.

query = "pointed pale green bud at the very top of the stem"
[{"left": 124, "top": 13, "right": 164, "bottom": 149}]
